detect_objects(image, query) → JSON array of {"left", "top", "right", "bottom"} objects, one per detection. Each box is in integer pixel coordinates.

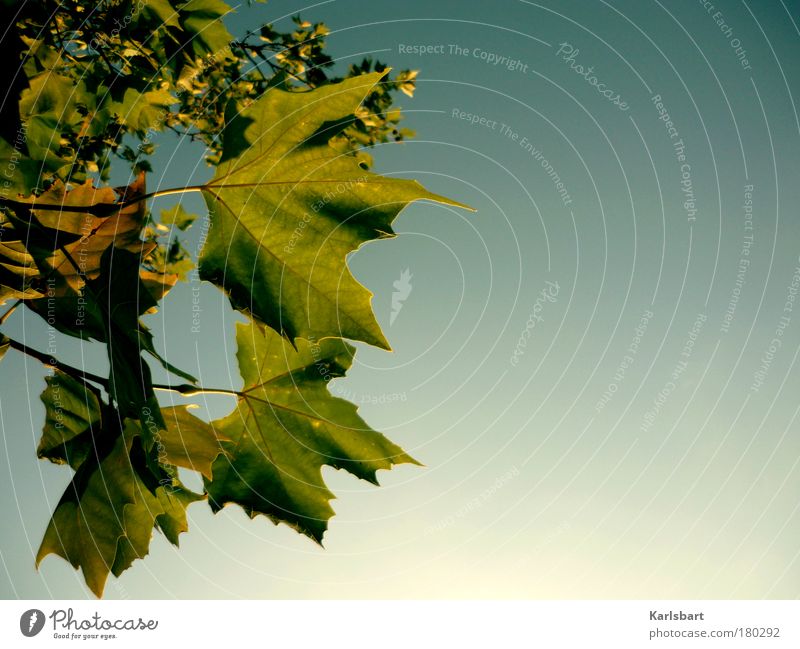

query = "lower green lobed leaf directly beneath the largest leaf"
[{"left": 206, "top": 324, "right": 417, "bottom": 542}]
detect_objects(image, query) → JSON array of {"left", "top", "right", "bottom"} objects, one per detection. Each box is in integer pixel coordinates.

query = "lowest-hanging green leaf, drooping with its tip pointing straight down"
[{"left": 36, "top": 420, "right": 202, "bottom": 597}]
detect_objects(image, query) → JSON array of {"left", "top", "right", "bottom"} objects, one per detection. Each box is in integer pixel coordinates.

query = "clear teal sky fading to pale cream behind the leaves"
[{"left": 0, "top": 0, "right": 800, "bottom": 598}]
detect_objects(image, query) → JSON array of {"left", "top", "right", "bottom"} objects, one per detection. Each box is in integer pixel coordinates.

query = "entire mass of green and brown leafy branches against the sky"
[{"left": 0, "top": 0, "right": 466, "bottom": 595}]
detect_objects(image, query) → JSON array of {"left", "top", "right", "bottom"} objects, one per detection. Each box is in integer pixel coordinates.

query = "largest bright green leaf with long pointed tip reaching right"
[{"left": 199, "top": 72, "right": 465, "bottom": 349}]
